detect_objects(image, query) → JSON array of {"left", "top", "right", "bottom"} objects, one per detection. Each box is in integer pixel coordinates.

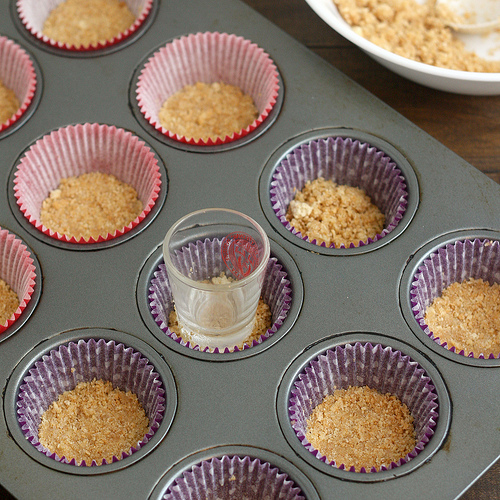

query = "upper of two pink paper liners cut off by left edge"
[{"left": 0, "top": 36, "right": 37, "bottom": 132}]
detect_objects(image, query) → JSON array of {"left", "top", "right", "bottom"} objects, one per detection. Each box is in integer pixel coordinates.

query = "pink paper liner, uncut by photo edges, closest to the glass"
[{"left": 14, "top": 123, "right": 161, "bottom": 243}]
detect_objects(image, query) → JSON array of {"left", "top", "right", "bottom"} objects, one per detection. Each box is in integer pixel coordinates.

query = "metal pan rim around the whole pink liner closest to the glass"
[{"left": 7, "top": 123, "right": 169, "bottom": 251}]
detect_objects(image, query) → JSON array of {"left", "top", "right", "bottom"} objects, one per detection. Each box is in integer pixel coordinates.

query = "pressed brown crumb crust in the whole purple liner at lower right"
[{"left": 306, "top": 386, "right": 416, "bottom": 472}]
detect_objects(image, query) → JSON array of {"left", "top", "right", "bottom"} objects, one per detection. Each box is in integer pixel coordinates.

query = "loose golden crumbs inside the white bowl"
[{"left": 332, "top": 0, "right": 500, "bottom": 73}]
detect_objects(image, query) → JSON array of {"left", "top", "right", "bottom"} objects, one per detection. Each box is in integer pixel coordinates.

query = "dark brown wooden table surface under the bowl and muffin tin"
[{"left": 240, "top": 0, "right": 500, "bottom": 500}]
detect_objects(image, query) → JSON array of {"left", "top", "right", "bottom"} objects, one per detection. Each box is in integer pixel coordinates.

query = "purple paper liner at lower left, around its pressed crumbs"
[{"left": 17, "top": 339, "right": 165, "bottom": 467}]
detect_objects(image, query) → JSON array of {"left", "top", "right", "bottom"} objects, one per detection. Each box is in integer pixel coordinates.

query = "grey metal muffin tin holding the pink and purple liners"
[{"left": 0, "top": 0, "right": 500, "bottom": 500}]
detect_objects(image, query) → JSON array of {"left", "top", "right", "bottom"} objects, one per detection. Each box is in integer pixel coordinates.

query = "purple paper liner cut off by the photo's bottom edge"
[{"left": 162, "top": 455, "right": 305, "bottom": 500}]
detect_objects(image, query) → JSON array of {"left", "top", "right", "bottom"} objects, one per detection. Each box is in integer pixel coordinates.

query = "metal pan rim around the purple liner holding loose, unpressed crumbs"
[{"left": 259, "top": 127, "right": 420, "bottom": 257}]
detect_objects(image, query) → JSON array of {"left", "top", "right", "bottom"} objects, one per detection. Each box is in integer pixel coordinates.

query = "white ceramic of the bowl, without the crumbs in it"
[{"left": 306, "top": 0, "right": 500, "bottom": 95}]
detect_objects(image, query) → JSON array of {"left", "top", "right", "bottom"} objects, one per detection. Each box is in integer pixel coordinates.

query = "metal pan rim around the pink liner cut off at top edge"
[{"left": 10, "top": 0, "right": 160, "bottom": 59}]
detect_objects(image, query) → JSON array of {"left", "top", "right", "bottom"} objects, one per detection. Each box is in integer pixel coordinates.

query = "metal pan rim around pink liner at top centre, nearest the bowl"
[{"left": 129, "top": 33, "right": 285, "bottom": 153}]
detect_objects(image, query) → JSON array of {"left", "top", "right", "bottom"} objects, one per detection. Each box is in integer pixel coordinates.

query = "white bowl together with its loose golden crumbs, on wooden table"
[{"left": 306, "top": 0, "right": 500, "bottom": 95}]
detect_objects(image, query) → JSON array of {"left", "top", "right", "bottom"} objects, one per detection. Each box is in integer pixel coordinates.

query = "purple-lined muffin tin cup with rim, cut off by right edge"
[{"left": 400, "top": 229, "right": 500, "bottom": 367}]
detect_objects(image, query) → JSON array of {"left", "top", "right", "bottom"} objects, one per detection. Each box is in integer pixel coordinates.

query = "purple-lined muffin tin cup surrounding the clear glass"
[{"left": 137, "top": 239, "right": 303, "bottom": 361}]
